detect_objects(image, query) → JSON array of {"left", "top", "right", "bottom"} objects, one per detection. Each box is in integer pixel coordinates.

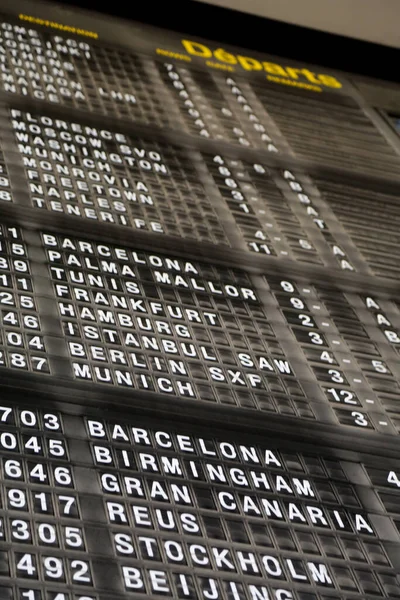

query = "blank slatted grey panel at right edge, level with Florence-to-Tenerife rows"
[{"left": 316, "top": 178, "right": 400, "bottom": 279}]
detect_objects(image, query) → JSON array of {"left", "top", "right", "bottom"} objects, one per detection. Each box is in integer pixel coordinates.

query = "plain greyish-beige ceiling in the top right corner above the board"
[{"left": 197, "top": 0, "right": 400, "bottom": 48}]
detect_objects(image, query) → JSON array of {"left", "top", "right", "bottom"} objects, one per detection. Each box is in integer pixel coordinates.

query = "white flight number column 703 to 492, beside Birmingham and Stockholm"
[{"left": 0, "top": 404, "right": 98, "bottom": 600}]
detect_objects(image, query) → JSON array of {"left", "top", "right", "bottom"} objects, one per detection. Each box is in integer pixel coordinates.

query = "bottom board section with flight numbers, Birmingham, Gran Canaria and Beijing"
[{"left": 0, "top": 402, "right": 400, "bottom": 600}]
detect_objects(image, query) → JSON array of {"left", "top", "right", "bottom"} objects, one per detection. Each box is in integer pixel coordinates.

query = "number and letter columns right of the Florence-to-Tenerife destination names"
[{"left": 204, "top": 154, "right": 356, "bottom": 271}]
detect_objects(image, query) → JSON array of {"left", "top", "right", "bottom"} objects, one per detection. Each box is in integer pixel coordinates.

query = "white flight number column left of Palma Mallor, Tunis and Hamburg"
[{"left": 0, "top": 222, "right": 65, "bottom": 376}]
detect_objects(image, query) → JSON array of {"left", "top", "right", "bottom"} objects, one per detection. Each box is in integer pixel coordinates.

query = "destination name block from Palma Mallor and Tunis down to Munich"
[{"left": 42, "top": 233, "right": 320, "bottom": 418}]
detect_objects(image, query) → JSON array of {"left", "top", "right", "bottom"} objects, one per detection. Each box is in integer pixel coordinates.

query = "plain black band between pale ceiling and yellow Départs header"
[{"left": 51, "top": 0, "right": 400, "bottom": 82}]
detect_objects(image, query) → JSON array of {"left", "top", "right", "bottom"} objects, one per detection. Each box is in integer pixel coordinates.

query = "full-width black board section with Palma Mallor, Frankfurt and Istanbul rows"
[{"left": 0, "top": 224, "right": 400, "bottom": 435}]
